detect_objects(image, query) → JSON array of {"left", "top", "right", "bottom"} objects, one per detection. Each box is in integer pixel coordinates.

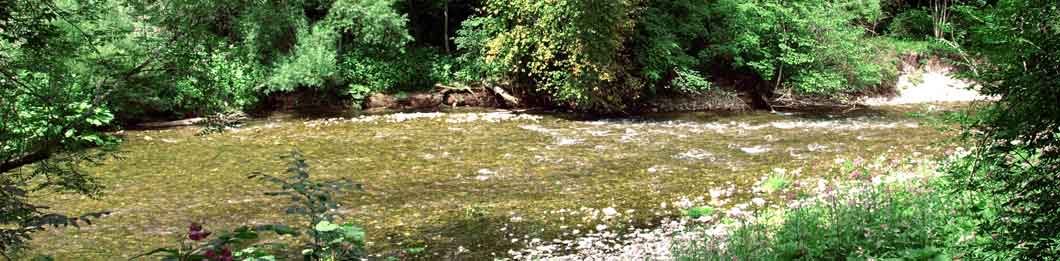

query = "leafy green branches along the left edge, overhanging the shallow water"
[{"left": 0, "top": 1, "right": 134, "bottom": 255}]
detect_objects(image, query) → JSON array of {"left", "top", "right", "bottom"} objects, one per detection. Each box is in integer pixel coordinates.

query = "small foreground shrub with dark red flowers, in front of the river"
[{"left": 134, "top": 151, "right": 365, "bottom": 261}]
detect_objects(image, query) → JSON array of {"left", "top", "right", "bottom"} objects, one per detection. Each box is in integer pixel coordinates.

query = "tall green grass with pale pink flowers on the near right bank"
[{"left": 674, "top": 159, "right": 977, "bottom": 260}]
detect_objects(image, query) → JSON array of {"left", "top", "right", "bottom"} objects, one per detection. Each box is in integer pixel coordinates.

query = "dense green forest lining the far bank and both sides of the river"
[{"left": 0, "top": 0, "right": 1060, "bottom": 260}]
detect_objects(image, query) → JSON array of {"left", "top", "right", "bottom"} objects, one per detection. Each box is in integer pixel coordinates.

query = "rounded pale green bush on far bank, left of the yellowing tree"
[{"left": 266, "top": 0, "right": 411, "bottom": 92}]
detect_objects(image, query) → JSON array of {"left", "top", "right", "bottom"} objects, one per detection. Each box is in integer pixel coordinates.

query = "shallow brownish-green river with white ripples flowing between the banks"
[{"left": 26, "top": 104, "right": 962, "bottom": 260}]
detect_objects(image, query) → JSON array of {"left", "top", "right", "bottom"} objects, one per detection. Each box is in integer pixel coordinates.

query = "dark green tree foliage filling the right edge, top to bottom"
[{"left": 950, "top": 1, "right": 1060, "bottom": 260}]
